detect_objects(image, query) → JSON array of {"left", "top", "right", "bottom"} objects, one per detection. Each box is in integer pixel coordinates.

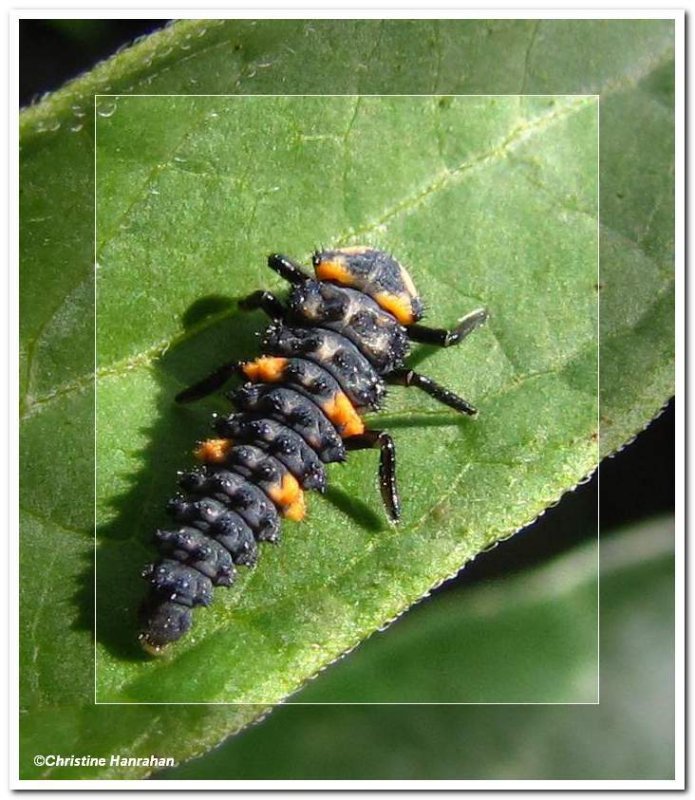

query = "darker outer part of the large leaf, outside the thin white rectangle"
[{"left": 20, "top": 20, "right": 673, "bottom": 777}]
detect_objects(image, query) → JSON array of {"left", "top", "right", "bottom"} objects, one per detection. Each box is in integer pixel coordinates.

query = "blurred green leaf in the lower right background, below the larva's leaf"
[{"left": 158, "top": 519, "right": 675, "bottom": 780}]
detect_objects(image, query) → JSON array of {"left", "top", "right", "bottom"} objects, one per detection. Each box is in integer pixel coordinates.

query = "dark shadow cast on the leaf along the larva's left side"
[{"left": 91, "top": 298, "right": 266, "bottom": 661}]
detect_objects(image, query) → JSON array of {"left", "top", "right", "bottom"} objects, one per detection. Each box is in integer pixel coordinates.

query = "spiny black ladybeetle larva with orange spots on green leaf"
[{"left": 139, "top": 247, "right": 487, "bottom": 654}]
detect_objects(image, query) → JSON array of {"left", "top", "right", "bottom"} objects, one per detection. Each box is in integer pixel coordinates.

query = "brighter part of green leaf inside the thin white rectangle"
[{"left": 96, "top": 90, "right": 598, "bottom": 704}]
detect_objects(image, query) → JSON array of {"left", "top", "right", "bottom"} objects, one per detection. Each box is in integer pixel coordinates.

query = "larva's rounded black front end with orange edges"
[{"left": 312, "top": 247, "right": 423, "bottom": 325}]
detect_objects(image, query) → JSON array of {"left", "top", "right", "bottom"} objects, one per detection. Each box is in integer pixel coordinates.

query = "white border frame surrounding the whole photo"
[{"left": 6, "top": 6, "right": 684, "bottom": 791}]
